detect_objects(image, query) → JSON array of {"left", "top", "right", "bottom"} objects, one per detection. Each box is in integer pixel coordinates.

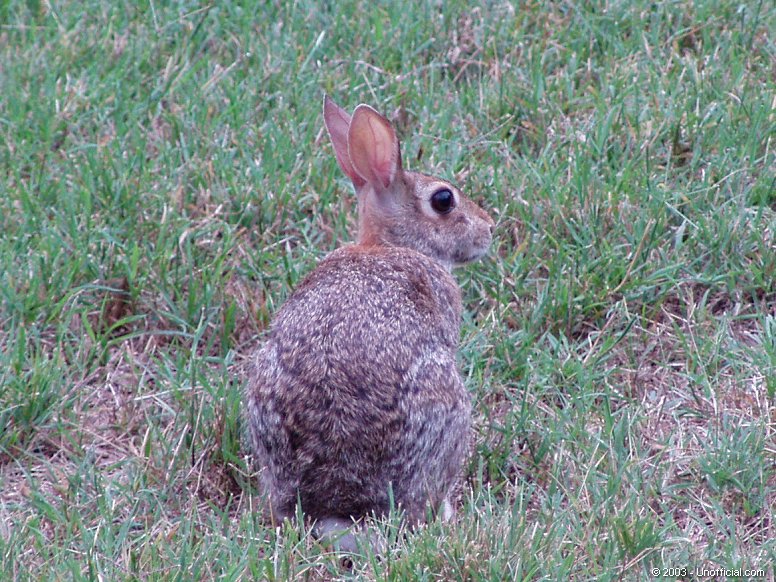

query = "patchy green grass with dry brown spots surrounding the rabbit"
[{"left": 0, "top": 0, "right": 776, "bottom": 580}]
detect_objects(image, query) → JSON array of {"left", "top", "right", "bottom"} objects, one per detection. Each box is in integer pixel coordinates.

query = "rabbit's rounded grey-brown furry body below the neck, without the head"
[{"left": 248, "top": 246, "right": 470, "bottom": 520}]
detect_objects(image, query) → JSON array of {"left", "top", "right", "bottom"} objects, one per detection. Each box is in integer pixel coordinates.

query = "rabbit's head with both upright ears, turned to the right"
[{"left": 323, "top": 97, "right": 494, "bottom": 269}]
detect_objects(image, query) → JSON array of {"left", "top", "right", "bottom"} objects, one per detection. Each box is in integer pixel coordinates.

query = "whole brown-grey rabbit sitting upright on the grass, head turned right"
[{"left": 245, "top": 97, "right": 494, "bottom": 552}]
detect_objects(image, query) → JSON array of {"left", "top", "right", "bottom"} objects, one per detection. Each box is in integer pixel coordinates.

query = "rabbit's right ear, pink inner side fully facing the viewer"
[{"left": 348, "top": 105, "right": 402, "bottom": 189}]
